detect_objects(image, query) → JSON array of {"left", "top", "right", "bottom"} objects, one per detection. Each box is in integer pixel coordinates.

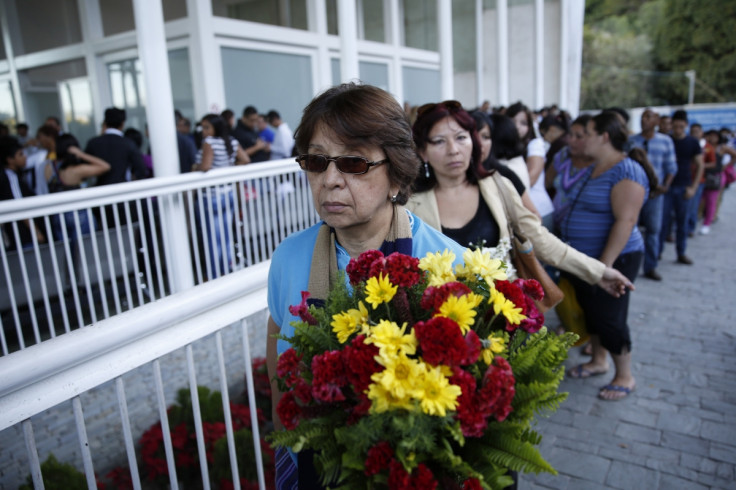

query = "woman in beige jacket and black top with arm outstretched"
[{"left": 407, "top": 101, "right": 633, "bottom": 297}]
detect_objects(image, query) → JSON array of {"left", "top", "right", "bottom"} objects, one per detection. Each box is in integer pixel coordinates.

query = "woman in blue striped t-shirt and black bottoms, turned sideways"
[{"left": 562, "top": 111, "right": 657, "bottom": 400}]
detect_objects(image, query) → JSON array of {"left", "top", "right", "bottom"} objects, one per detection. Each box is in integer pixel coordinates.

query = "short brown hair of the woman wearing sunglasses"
[{"left": 294, "top": 83, "right": 420, "bottom": 204}]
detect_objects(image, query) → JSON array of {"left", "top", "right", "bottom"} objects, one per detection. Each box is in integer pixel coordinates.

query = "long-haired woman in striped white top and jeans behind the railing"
[{"left": 193, "top": 114, "right": 250, "bottom": 277}]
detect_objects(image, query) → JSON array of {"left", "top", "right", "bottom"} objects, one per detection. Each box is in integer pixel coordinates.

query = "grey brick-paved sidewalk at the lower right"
[{"left": 519, "top": 189, "right": 736, "bottom": 490}]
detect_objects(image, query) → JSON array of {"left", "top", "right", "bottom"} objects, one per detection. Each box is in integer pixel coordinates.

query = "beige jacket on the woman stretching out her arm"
[{"left": 406, "top": 177, "right": 606, "bottom": 284}]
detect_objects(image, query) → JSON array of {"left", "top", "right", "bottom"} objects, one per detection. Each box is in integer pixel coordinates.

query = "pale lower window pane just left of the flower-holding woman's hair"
[{"left": 222, "top": 48, "right": 314, "bottom": 130}]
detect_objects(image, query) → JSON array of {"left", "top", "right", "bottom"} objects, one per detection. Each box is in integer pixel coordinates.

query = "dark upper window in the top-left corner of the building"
[{"left": 11, "top": 0, "right": 82, "bottom": 56}]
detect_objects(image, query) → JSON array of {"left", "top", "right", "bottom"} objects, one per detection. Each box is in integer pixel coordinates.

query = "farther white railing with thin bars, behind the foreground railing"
[{"left": 0, "top": 160, "right": 317, "bottom": 355}]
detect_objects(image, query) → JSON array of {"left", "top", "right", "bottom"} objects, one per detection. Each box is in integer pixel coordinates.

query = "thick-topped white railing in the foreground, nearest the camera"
[{"left": 0, "top": 262, "right": 269, "bottom": 489}]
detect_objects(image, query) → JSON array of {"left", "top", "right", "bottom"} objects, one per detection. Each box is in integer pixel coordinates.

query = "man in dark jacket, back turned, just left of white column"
[{"left": 84, "top": 107, "right": 147, "bottom": 185}]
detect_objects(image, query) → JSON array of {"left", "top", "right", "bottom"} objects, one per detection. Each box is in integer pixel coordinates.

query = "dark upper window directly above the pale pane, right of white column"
[{"left": 212, "top": 0, "right": 307, "bottom": 30}]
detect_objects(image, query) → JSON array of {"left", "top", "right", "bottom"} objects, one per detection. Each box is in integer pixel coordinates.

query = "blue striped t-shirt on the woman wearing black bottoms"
[{"left": 561, "top": 158, "right": 649, "bottom": 259}]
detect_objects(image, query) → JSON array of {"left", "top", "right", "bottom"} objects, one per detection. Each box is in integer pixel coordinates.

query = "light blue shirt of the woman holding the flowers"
[{"left": 268, "top": 213, "right": 465, "bottom": 354}]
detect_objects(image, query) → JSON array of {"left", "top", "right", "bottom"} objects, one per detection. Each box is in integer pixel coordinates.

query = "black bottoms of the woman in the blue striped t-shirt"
[{"left": 563, "top": 252, "right": 644, "bottom": 355}]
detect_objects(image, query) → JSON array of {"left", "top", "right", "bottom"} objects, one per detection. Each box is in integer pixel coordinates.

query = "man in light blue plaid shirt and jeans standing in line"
[{"left": 629, "top": 108, "right": 677, "bottom": 281}]
